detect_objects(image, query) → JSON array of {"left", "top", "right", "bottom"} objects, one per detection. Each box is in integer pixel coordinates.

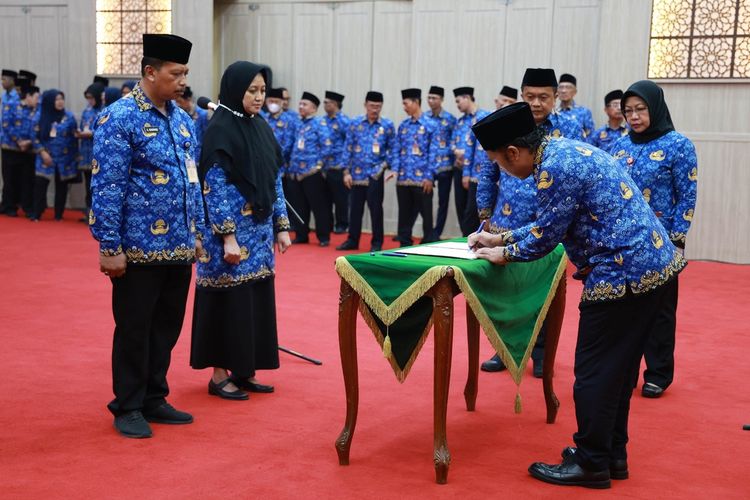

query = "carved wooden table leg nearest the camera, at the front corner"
[{"left": 432, "top": 278, "right": 453, "bottom": 484}]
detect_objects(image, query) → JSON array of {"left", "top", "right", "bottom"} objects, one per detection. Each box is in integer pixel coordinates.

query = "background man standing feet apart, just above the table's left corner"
[{"left": 336, "top": 90, "right": 398, "bottom": 252}]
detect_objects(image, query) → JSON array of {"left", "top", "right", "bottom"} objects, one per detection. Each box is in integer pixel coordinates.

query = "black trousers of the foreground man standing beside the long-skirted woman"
[{"left": 107, "top": 265, "right": 192, "bottom": 416}]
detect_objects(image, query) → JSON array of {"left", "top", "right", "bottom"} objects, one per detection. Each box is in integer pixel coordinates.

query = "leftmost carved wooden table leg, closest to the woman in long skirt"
[{"left": 336, "top": 279, "right": 360, "bottom": 465}]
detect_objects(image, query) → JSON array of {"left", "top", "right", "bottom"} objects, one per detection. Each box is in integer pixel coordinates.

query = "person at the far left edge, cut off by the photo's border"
[{"left": 0, "top": 69, "right": 21, "bottom": 217}]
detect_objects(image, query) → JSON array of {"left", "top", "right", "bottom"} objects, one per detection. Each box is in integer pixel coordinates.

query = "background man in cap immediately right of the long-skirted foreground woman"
[{"left": 287, "top": 92, "right": 332, "bottom": 247}]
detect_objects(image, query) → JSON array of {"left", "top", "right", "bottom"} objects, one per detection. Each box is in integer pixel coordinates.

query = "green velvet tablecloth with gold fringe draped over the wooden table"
[{"left": 336, "top": 238, "right": 567, "bottom": 384}]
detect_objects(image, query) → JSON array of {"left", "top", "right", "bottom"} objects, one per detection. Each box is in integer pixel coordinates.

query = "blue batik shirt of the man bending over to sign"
[{"left": 502, "top": 139, "right": 686, "bottom": 302}]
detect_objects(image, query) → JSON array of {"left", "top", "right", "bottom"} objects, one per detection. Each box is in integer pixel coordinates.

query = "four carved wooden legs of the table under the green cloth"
[{"left": 335, "top": 269, "right": 566, "bottom": 484}]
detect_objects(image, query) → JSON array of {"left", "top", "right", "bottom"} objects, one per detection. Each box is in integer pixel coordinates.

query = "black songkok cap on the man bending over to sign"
[{"left": 471, "top": 102, "right": 536, "bottom": 151}]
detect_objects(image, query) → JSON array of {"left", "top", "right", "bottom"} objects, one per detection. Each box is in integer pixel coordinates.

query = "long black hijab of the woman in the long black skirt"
[{"left": 198, "top": 61, "right": 282, "bottom": 219}]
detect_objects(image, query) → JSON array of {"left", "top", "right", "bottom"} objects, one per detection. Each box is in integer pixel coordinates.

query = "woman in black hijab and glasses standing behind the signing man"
[{"left": 610, "top": 80, "right": 698, "bottom": 398}]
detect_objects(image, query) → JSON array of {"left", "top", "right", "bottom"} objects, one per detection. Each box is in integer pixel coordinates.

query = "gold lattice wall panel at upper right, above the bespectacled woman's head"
[{"left": 648, "top": 0, "right": 750, "bottom": 79}]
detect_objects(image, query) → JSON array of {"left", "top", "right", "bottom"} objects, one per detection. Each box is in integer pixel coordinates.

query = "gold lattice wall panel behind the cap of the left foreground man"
[{"left": 96, "top": 0, "right": 172, "bottom": 75}]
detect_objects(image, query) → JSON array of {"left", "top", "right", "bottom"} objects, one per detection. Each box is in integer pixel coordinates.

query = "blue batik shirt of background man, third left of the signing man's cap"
[{"left": 396, "top": 113, "right": 439, "bottom": 186}]
